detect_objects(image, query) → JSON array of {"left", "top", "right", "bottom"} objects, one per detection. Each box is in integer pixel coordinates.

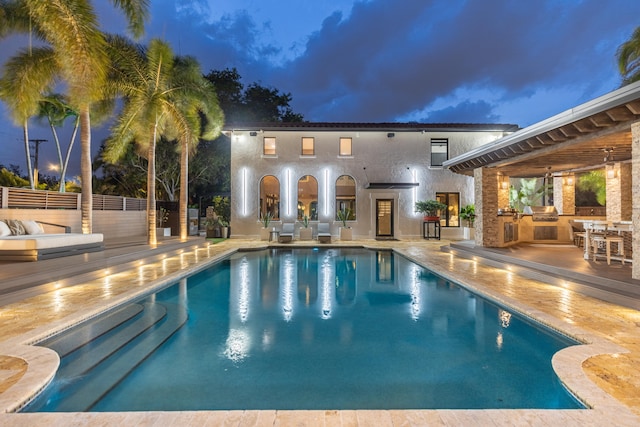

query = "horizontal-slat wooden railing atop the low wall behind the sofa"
[{"left": 0, "top": 187, "right": 147, "bottom": 211}]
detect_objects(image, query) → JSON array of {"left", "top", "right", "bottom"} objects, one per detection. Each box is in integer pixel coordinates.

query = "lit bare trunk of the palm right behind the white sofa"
[{"left": 80, "top": 107, "right": 93, "bottom": 234}]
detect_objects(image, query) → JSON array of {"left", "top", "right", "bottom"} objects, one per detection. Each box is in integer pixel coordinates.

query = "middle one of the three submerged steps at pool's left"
[{"left": 58, "top": 303, "right": 167, "bottom": 378}]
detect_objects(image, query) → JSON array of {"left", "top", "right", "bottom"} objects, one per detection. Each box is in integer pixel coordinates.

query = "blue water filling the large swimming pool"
[{"left": 26, "top": 248, "right": 583, "bottom": 411}]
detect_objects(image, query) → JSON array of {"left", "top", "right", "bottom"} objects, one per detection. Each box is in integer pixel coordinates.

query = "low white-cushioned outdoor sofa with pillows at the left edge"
[{"left": 0, "top": 219, "right": 104, "bottom": 261}]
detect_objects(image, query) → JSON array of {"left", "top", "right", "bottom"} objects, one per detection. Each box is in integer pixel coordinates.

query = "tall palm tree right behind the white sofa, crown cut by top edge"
[{"left": 0, "top": 0, "right": 149, "bottom": 233}]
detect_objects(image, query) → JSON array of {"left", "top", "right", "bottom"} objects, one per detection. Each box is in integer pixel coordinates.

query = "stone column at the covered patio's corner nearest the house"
[{"left": 473, "top": 168, "right": 509, "bottom": 248}]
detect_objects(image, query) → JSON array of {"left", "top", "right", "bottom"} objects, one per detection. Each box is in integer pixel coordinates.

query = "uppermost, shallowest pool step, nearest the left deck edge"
[{"left": 38, "top": 304, "right": 144, "bottom": 357}]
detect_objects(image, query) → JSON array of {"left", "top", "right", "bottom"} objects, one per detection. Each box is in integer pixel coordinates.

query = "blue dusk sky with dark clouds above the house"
[{"left": 0, "top": 0, "right": 640, "bottom": 177}]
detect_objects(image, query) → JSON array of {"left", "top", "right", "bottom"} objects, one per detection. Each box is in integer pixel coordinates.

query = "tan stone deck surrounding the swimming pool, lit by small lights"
[{"left": 0, "top": 238, "right": 640, "bottom": 427}]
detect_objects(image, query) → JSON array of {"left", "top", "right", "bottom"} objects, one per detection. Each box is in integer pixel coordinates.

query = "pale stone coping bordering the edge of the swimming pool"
[{"left": 0, "top": 242, "right": 640, "bottom": 425}]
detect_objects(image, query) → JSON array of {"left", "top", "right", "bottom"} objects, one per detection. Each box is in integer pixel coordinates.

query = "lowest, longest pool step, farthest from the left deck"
[{"left": 56, "top": 303, "right": 188, "bottom": 412}]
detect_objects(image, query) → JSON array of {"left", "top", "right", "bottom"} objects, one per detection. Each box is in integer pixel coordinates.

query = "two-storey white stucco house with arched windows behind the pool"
[{"left": 224, "top": 122, "right": 518, "bottom": 239}]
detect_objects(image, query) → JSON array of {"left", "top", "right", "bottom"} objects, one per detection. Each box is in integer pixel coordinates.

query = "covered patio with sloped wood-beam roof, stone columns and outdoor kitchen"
[{"left": 444, "top": 82, "right": 640, "bottom": 279}]
